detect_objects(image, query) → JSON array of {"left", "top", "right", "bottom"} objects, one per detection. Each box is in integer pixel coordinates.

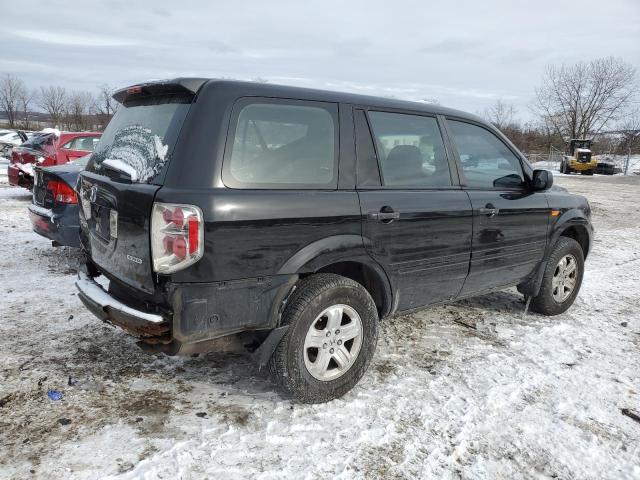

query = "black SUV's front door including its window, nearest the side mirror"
[{"left": 447, "top": 119, "right": 550, "bottom": 295}]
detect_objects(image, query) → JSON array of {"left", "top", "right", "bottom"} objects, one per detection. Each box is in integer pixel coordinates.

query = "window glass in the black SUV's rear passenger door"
[{"left": 369, "top": 112, "right": 451, "bottom": 187}]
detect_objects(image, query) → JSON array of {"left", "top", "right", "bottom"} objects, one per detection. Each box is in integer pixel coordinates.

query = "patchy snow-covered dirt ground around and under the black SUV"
[{"left": 0, "top": 176, "right": 640, "bottom": 479}]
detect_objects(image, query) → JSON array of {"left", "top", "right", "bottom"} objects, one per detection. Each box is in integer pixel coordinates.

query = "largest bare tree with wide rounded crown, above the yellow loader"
[{"left": 534, "top": 57, "right": 636, "bottom": 139}]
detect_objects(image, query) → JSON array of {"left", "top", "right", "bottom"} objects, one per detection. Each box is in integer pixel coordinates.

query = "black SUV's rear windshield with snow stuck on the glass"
[{"left": 91, "top": 95, "right": 193, "bottom": 183}]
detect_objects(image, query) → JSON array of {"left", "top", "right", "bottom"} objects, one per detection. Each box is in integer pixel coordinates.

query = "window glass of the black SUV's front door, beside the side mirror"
[{"left": 448, "top": 120, "right": 524, "bottom": 188}]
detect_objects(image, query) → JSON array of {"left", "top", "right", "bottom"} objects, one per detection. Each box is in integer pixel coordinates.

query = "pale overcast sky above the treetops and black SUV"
[{"left": 0, "top": 0, "right": 640, "bottom": 118}]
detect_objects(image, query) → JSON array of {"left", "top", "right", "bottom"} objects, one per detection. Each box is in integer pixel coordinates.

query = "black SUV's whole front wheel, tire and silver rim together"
[{"left": 531, "top": 237, "right": 584, "bottom": 315}]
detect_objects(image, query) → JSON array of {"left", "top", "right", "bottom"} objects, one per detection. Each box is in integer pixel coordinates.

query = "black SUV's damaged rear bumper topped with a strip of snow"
[{"left": 76, "top": 271, "right": 171, "bottom": 342}]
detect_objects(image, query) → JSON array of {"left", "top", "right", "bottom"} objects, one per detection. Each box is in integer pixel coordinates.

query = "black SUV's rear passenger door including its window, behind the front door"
[{"left": 354, "top": 109, "right": 472, "bottom": 310}]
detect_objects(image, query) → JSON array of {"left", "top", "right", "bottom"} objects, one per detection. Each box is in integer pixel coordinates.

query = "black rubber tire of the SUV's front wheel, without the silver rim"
[{"left": 531, "top": 237, "right": 584, "bottom": 315}]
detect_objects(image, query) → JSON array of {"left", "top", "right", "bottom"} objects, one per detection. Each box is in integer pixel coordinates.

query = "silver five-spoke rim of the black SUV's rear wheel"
[{"left": 304, "top": 304, "right": 362, "bottom": 382}]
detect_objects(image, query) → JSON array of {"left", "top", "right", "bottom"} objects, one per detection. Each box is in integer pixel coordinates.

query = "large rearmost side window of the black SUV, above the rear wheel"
[{"left": 223, "top": 100, "right": 338, "bottom": 188}]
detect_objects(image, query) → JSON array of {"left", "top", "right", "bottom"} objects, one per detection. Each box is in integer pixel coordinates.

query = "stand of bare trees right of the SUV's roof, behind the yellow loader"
[{"left": 483, "top": 57, "right": 640, "bottom": 154}]
